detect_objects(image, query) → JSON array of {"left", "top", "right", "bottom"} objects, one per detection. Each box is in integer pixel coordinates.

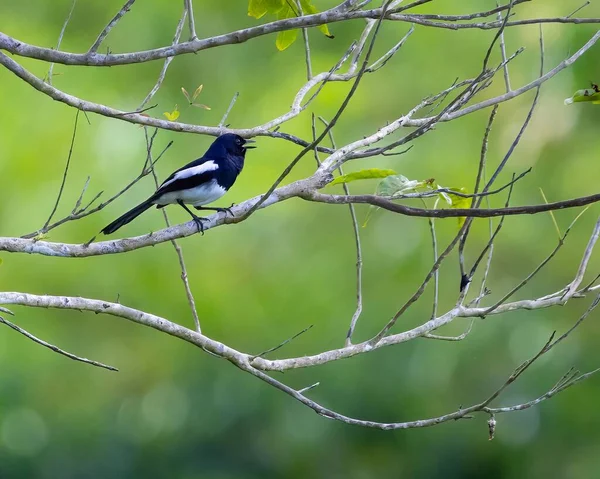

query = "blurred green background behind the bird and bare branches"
[{"left": 0, "top": 0, "right": 600, "bottom": 479}]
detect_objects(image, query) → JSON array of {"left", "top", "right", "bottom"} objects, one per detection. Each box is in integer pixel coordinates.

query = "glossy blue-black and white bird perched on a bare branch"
[{"left": 101, "top": 133, "right": 256, "bottom": 235}]
